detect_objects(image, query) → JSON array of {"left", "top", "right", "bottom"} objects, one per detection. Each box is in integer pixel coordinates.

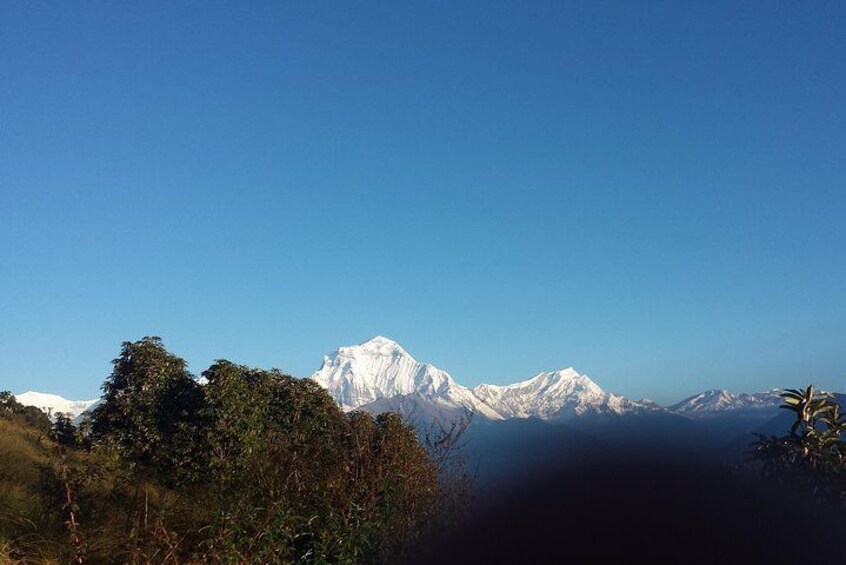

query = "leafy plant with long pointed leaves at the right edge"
[{"left": 750, "top": 385, "right": 846, "bottom": 501}]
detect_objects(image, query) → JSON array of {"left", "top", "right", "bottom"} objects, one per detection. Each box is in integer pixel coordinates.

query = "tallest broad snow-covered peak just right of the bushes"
[{"left": 311, "top": 336, "right": 502, "bottom": 420}]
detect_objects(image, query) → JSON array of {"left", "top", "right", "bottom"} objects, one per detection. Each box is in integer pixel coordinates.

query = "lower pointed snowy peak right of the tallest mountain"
[{"left": 473, "top": 367, "right": 663, "bottom": 420}]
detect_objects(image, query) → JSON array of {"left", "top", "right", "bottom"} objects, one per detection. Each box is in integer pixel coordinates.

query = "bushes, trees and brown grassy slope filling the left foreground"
[{"left": 0, "top": 337, "right": 470, "bottom": 564}]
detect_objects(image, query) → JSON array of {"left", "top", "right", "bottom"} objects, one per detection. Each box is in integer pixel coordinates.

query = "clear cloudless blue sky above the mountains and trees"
[{"left": 0, "top": 0, "right": 846, "bottom": 402}]
